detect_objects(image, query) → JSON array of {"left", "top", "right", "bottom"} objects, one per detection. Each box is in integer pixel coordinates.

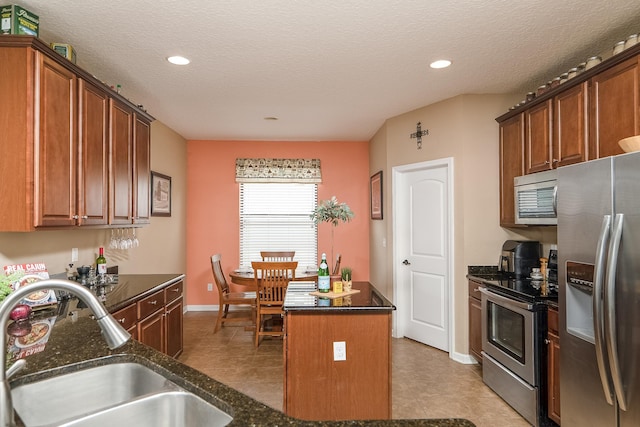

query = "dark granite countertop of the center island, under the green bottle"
[{"left": 283, "top": 282, "right": 396, "bottom": 313}]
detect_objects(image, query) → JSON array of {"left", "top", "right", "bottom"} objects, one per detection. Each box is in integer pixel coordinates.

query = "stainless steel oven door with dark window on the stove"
[{"left": 480, "top": 288, "right": 538, "bottom": 386}]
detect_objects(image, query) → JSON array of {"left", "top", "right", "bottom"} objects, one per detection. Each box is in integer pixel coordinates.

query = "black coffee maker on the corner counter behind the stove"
[{"left": 498, "top": 240, "right": 542, "bottom": 279}]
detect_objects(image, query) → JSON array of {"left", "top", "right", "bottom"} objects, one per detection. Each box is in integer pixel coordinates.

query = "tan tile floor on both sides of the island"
[{"left": 179, "top": 312, "right": 529, "bottom": 427}]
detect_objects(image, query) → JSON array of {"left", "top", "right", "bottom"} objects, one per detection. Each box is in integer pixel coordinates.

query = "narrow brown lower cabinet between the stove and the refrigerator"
[{"left": 547, "top": 307, "right": 560, "bottom": 425}]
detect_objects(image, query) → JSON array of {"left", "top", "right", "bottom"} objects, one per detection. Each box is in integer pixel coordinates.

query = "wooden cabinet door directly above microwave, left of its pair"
[{"left": 524, "top": 100, "right": 552, "bottom": 174}]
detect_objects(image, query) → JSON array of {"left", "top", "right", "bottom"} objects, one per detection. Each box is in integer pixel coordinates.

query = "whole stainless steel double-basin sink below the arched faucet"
[{"left": 11, "top": 362, "right": 232, "bottom": 427}]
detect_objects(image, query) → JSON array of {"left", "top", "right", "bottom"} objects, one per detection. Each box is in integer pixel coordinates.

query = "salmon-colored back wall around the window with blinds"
[{"left": 187, "top": 141, "right": 369, "bottom": 310}]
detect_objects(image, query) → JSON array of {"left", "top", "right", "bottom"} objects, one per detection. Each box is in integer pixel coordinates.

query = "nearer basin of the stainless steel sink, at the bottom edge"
[{"left": 62, "top": 391, "right": 232, "bottom": 427}]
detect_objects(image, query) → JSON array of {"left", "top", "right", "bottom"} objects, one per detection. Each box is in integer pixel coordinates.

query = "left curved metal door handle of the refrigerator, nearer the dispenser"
[{"left": 592, "top": 215, "right": 613, "bottom": 406}]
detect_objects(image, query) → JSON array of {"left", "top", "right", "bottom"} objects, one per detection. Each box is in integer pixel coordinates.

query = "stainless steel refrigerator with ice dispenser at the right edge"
[{"left": 557, "top": 152, "right": 640, "bottom": 427}]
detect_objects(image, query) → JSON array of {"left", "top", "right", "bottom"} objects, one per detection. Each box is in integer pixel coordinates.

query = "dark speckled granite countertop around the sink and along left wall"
[{"left": 6, "top": 275, "right": 474, "bottom": 427}]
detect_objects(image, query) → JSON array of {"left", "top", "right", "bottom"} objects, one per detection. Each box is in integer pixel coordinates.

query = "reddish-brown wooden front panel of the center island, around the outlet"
[{"left": 284, "top": 311, "right": 391, "bottom": 420}]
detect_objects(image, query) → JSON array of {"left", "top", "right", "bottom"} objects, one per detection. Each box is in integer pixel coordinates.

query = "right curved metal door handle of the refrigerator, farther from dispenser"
[{"left": 604, "top": 214, "right": 627, "bottom": 411}]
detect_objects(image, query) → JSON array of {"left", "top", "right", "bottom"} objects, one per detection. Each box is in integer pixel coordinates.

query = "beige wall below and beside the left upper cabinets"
[{"left": 0, "top": 121, "right": 186, "bottom": 284}]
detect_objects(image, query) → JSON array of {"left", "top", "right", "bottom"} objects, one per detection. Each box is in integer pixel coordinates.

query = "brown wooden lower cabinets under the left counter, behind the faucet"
[{"left": 113, "top": 281, "right": 183, "bottom": 357}]
